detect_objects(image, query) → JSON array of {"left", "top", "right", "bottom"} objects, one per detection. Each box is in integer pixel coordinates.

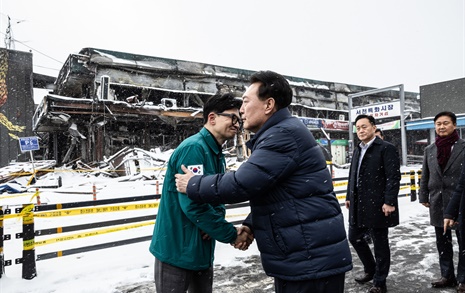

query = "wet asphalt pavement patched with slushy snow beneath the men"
[{"left": 114, "top": 207, "right": 457, "bottom": 293}]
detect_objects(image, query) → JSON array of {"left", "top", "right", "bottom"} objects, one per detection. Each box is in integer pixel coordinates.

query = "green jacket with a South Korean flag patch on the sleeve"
[{"left": 150, "top": 128, "right": 237, "bottom": 271}]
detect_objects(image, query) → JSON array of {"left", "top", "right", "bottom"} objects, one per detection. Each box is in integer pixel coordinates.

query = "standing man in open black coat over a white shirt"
[{"left": 345, "top": 115, "right": 401, "bottom": 293}]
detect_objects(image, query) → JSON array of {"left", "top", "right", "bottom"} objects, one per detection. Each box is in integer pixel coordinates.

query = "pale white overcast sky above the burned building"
[{"left": 0, "top": 0, "right": 465, "bottom": 92}]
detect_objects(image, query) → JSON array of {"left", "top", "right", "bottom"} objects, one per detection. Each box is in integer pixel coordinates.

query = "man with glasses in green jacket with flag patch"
[{"left": 150, "top": 94, "right": 253, "bottom": 293}]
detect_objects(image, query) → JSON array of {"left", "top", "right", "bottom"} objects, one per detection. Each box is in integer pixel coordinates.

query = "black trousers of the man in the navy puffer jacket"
[{"left": 274, "top": 273, "right": 346, "bottom": 293}]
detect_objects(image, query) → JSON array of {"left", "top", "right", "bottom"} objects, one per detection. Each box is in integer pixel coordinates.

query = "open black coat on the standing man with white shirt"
[{"left": 346, "top": 137, "right": 401, "bottom": 228}]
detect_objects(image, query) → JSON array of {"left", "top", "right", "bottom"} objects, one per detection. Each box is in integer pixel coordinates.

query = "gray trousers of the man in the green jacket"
[{"left": 155, "top": 258, "right": 213, "bottom": 293}]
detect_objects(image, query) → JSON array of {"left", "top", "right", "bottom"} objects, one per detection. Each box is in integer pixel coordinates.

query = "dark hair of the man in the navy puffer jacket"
[{"left": 250, "top": 70, "right": 292, "bottom": 110}]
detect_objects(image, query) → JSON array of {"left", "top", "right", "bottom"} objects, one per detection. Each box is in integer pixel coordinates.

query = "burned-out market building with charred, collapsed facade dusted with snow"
[{"left": 33, "top": 48, "right": 416, "bottom": 162}]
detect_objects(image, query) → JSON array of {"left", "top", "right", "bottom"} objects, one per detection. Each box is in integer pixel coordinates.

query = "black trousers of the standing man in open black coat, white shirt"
[{"left": 349, "top": 226, "right": 391, "bottom": 287}]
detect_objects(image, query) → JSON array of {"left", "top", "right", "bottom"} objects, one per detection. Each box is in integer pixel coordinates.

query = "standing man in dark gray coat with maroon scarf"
[{"left": 419, "top": 111, "right": 465, "bottom": 292}]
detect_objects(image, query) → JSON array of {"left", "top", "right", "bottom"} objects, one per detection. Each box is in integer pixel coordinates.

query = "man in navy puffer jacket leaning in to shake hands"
[{"left": 176, "top": 71, "right": 352, "bottom": 293}]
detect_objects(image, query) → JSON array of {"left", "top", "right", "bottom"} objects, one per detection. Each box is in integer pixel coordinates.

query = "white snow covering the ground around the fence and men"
[{"left": 0, "top": 164, "right": 453, "bottom": 293}]
